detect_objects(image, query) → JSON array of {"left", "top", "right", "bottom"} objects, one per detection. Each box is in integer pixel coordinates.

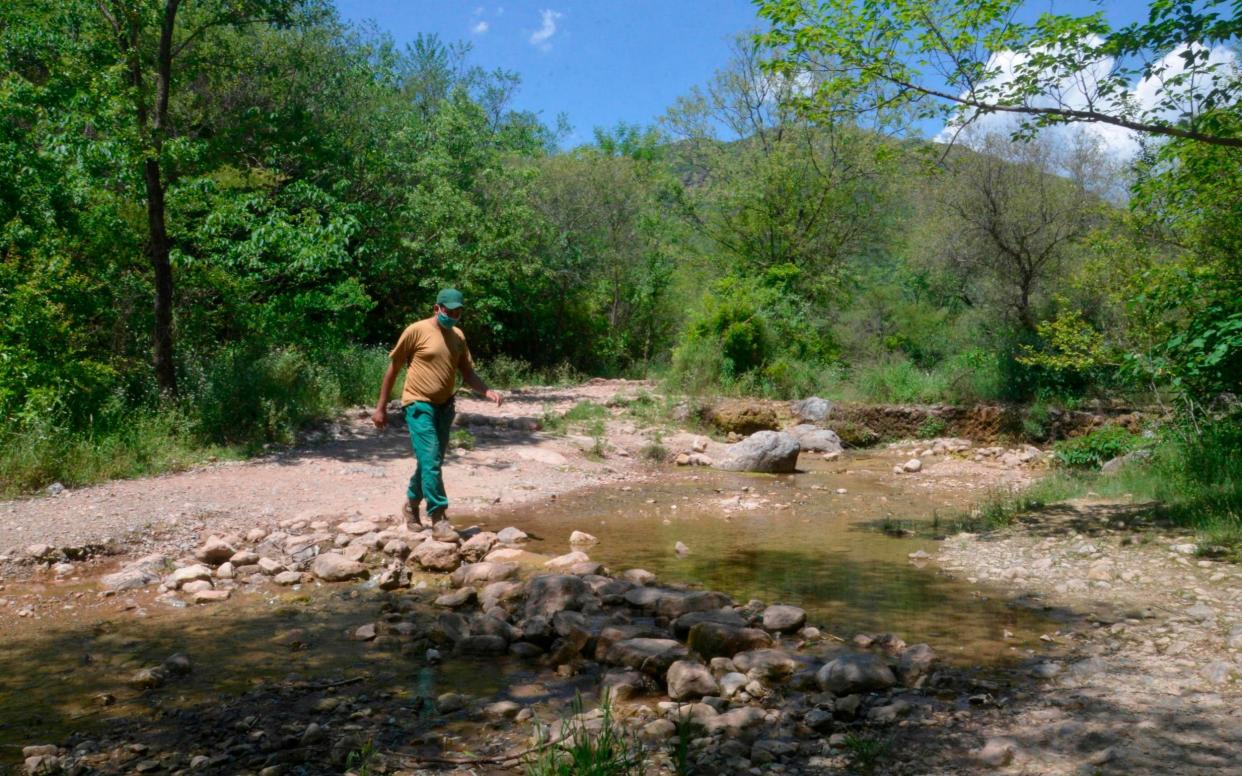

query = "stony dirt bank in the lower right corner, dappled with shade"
[{"left": 940, "top": 500, "right": 1242, "bottom": 774}]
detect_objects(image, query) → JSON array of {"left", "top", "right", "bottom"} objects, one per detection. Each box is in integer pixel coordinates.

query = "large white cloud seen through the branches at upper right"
[{"left": 935, "top": 40, "right": 1237, "bottom": 159}]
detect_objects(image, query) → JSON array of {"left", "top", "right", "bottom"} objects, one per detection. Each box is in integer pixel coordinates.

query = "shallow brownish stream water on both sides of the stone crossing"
[{"left": 0, "top": 456, "right": 1056, "bottom": 764}]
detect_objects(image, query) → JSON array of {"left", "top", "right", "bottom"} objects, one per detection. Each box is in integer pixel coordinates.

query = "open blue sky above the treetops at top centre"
[{"left": 327, "top": 0, "right": 1148, "bottom": 147}]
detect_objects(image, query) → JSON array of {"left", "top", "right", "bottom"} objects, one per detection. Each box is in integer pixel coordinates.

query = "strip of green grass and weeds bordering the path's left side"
[{"left": 0, "top": 348, "right": 388, "bottom": 497}]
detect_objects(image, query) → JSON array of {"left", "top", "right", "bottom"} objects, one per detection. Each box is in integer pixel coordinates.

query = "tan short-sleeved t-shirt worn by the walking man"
[{"left": 389, "top": 318, "right": 474, "bottom": 406}]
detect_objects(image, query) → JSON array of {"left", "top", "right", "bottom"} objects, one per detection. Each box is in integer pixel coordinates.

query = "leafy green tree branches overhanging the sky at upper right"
[{"left": 759, "top": 0, "right": 1242, "bottom": 148}]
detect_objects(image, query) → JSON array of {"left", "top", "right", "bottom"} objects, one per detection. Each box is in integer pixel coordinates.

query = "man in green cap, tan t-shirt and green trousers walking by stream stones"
[{"left": 371, "top": 288, "right": 501, "bottom": 525}]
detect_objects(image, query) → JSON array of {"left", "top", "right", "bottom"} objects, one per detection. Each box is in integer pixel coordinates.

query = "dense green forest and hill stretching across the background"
[{"left": 0, "top": 0, "right": 1242, "bottom": 506}]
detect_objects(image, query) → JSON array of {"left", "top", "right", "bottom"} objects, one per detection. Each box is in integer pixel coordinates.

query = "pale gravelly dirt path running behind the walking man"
[{"left": 0, "top": 380, "right": 652, "bottom": 564}]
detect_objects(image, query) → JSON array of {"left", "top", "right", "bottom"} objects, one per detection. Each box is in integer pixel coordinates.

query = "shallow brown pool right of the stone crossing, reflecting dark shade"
[{"left": 487, "top": 457, "right": 1048, "bottom": 661}]
